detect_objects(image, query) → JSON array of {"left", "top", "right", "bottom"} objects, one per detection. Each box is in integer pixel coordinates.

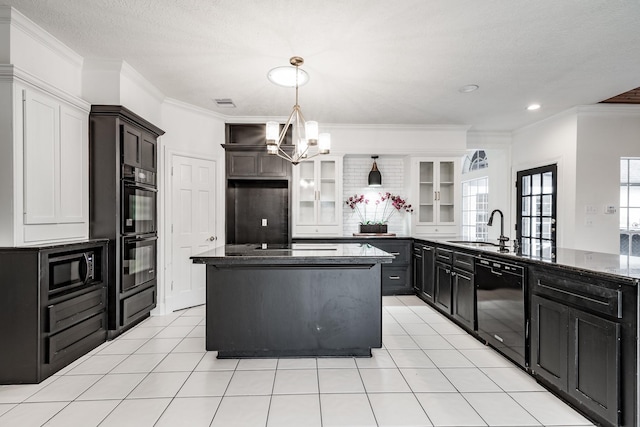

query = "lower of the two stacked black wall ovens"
[{"left": 122, "top": 234, "right": 158, "bottom": 292}]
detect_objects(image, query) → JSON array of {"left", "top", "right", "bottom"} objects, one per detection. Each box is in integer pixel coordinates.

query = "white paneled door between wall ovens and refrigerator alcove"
[{"left": 166, "top": 155, "right": 218, "bottom": 311}]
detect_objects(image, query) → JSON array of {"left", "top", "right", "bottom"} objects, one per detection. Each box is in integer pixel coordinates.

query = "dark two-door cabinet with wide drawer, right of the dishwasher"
[{"left": 531, "top": 271, "right": 635, "bottom": 426}]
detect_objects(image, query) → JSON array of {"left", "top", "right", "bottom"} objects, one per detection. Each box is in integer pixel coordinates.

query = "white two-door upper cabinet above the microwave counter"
[{"left": 0, "top": 83, "right": 89, "bottom": 246}]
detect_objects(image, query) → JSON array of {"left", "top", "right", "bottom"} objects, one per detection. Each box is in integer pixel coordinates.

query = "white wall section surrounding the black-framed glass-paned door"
[{"left": 511, "top": 109, "right": 578, "bottom": 249}]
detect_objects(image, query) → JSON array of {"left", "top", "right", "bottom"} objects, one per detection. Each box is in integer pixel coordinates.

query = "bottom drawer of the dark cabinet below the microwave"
[{"left": 46, "top": 313, "right": 107, "bottom": 364}]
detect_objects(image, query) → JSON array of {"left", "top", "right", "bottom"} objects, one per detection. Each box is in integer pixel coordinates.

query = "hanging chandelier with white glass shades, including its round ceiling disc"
[{"left": 266, "top": 56, "right": 331, "bottom": 165}]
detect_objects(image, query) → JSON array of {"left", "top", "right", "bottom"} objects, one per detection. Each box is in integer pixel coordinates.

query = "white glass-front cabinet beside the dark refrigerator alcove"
[{"left": 292, "top": 156, "right": 343, "bottom": 237}]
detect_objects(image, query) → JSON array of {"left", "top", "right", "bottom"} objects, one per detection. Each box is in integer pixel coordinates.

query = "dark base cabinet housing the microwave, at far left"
[{"left": 0, "top": 240, "right": 108, "bottom": 384}]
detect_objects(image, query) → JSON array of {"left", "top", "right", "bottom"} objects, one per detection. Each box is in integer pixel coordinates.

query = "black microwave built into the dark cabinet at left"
[{"left": 49, "top": 251, "right": 100, "bottom": 293}]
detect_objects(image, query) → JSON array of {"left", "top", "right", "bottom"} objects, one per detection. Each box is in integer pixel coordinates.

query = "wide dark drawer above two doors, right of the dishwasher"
[{"left": 532, "top": 271, "right": 623, "bottom": 319}]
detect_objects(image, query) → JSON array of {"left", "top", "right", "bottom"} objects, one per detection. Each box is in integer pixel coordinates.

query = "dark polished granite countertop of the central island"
[{"left": 191, "top": 243, "right": 394, "bottom": 265}]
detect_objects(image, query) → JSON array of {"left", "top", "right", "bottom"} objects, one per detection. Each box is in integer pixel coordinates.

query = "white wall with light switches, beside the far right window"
[{"left": 574, "top": 104, "right": 640, "bottom": 254}]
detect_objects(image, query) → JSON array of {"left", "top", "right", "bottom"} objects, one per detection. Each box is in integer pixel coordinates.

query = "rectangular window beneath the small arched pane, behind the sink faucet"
[{"left": 462, "top": 177, "right": 489, "bottom": 241}]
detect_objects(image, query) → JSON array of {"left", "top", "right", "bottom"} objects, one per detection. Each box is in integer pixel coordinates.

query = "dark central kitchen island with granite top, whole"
[{"left": 191, "top": 243, "right": 393, "bottom": 358}]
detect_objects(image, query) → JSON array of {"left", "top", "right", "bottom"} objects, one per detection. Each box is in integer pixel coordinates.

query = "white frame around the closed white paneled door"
[{"left": 158, "top": 147, "right": 226, "bottom": 315}]
